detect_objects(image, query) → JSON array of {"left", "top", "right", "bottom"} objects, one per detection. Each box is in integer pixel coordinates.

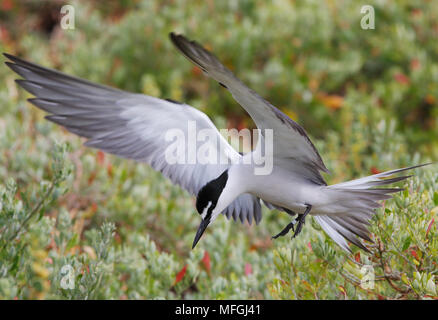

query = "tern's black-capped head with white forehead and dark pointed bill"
[{"left": 192, "top": 170, "right": 228, "bottom": 249}]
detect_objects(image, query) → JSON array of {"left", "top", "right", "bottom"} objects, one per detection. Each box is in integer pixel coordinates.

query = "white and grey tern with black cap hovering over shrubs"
[{"left": 4, "top": 33, "right": 428, "bottom": 252}]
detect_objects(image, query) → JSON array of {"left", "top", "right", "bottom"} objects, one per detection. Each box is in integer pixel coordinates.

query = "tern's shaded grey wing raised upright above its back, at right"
[{"left": 170, "top": 33, "right": 328, "bottom": 185}]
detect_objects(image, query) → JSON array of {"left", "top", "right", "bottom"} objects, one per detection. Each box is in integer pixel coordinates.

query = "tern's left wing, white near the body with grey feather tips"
[{"left": 4, "top": 54, "right": 261, "bottom": 223}]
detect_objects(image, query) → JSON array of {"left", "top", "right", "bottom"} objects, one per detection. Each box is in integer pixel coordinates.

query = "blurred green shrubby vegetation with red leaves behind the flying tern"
[{"left": 0, "top": 0, "right": 438, "bottom": 299}]
